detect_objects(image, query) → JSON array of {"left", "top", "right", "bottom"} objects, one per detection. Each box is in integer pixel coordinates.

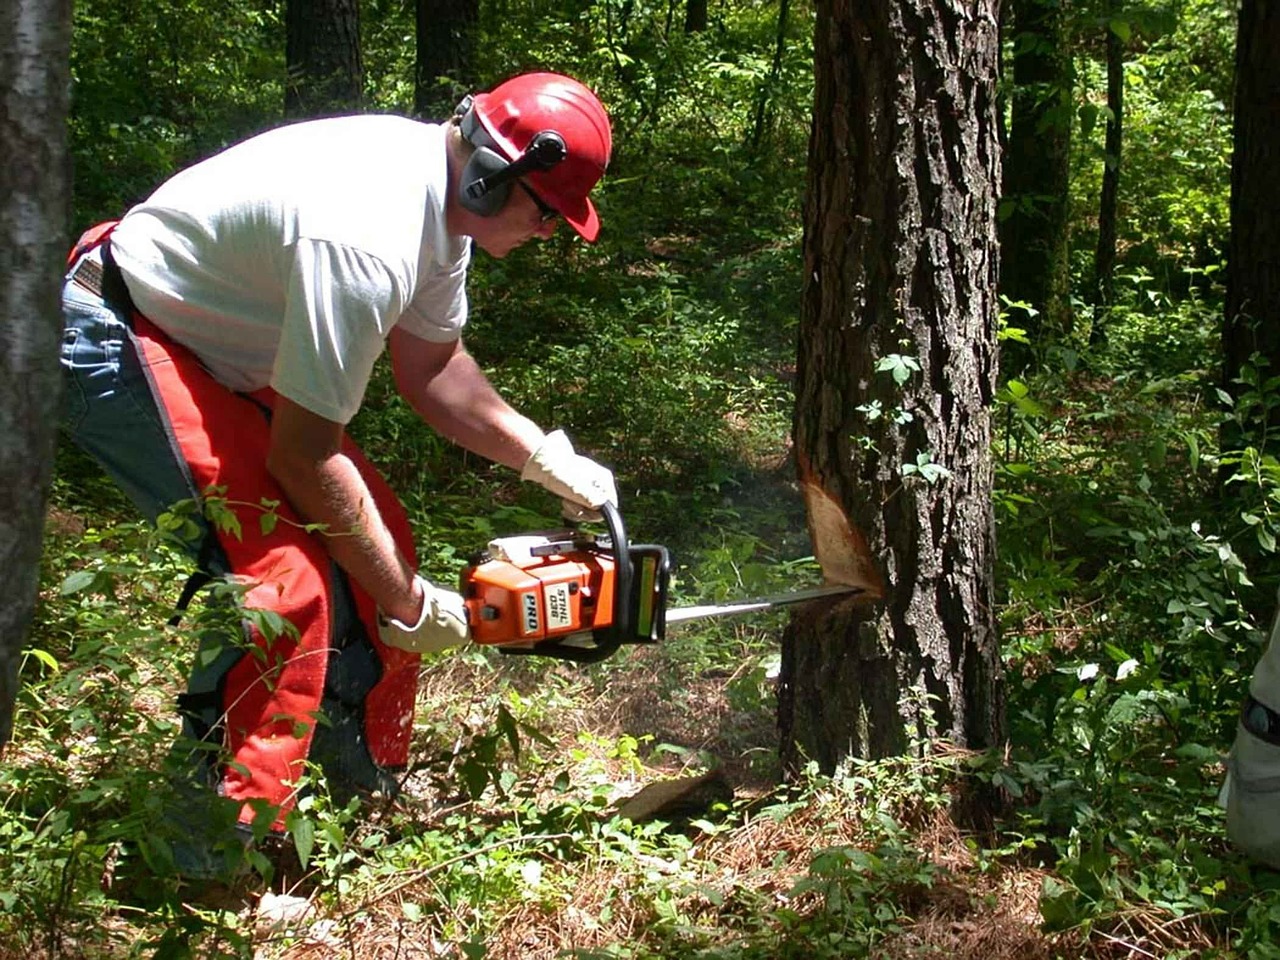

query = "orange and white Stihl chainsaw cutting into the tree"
[{"left": 461, "top": 503, "right": 859, "bottom": 663}]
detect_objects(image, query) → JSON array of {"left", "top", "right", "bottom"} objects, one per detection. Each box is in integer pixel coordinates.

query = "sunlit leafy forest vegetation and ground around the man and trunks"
[{"left": 0, "top": 0, "right": 1280, "bottom": 959}]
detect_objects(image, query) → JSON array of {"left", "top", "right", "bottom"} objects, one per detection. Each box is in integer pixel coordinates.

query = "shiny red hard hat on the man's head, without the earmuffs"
[{"left": 474, "top": 73, "right": 613, "bottom": 241}]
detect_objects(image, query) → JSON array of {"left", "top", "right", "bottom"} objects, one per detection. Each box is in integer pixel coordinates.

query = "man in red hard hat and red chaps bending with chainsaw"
[{"left": 63, "top": 73, "right": 617, "bottom": 870}]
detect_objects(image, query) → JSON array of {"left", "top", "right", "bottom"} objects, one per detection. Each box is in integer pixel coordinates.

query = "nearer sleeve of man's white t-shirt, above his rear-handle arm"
[{"left": 271, "top": 239, "right": 404, "bottom": 424}]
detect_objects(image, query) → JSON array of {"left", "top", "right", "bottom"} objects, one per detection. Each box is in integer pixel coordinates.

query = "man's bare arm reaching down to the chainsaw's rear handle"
[{"left": 266, "top": 397, "right": 424, "bottom": 623}]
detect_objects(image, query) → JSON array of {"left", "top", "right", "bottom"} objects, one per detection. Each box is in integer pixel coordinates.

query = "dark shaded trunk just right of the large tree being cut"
[{"left": 1000, "top": 0, "right": 1074, "bottom": 358}]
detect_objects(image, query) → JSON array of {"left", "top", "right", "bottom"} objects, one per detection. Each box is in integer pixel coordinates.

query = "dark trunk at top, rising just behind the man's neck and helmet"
[{"left": 413, "top": 0, "right": 480, "bottom": 119}]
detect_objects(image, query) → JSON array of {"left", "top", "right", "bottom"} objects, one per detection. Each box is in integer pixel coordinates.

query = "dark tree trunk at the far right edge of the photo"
[{"left": 1221, "top": 0, "right": 1280, "bottom": 463}]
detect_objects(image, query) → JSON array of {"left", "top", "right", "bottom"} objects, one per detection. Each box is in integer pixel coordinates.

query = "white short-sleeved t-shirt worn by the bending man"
[{"left": 111, "top": 115, "right": 470, "bottom": 424}]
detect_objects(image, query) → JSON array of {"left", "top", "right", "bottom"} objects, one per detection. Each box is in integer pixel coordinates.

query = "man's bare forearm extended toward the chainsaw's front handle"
[{"left": 390, "top": 330, "right": 545, "bottom": 470}]
